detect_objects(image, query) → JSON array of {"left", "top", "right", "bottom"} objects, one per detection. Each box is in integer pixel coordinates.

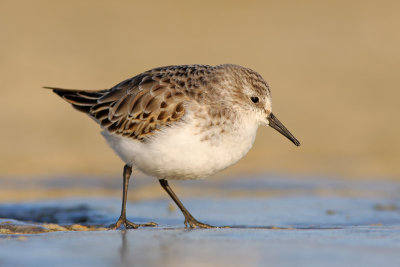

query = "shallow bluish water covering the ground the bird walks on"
[{"left": 0, "top": 176, "right": 400, "bottom": 266}]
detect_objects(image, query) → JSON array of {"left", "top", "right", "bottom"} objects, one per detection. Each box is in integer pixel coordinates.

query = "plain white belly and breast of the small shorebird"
[{"left": 103, "top": 117, "right": 258, "bottom": 179}]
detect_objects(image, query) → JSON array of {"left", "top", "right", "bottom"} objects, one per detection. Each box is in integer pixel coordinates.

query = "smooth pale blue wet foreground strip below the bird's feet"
[{"left": 0, "top": 226, "right": 400, "bottom": 266}]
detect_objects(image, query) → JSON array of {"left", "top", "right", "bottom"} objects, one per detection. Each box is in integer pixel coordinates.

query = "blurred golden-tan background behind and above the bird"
[{"left": 0, "top": 0, "right": 400, "bottom": 179}]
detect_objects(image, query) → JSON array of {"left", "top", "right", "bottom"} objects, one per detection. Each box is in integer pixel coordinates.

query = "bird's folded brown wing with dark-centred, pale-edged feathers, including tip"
[{"left": 47, "top": 70, "right": 188, "bottom": 140}]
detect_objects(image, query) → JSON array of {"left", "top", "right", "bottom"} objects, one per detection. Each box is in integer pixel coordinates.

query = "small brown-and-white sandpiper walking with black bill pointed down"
[{"left": 44, "top": 64, "right": 300, "bottom": 229}]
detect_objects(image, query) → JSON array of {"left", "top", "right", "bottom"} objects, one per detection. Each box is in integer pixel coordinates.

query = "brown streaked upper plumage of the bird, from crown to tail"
[{"left": 51, "top": 65, "right": 270, "bottom": 140}]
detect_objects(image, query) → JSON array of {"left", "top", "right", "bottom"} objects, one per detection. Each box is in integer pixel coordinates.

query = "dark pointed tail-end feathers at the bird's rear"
[{"left": 44, "top": 86, "right": 108, "bottom": 114}]
